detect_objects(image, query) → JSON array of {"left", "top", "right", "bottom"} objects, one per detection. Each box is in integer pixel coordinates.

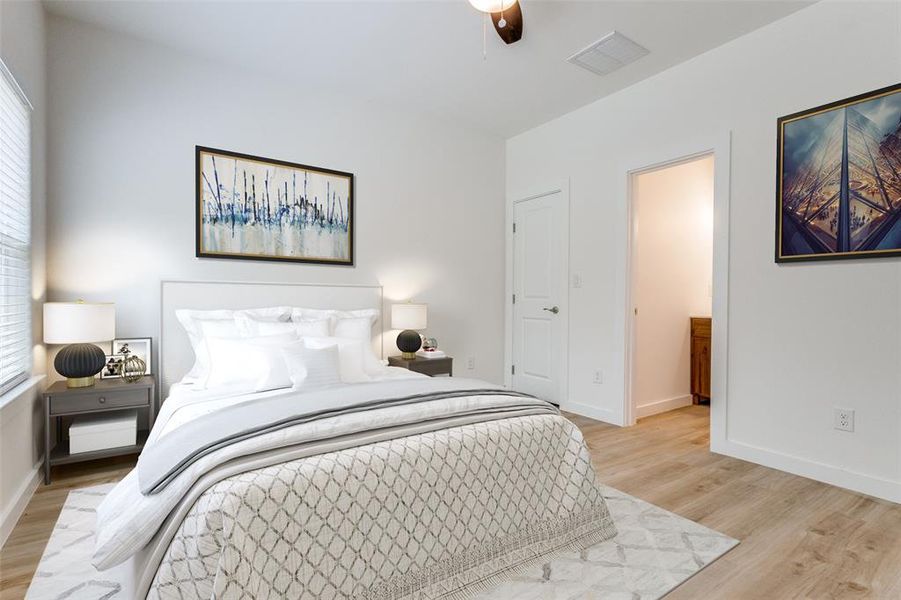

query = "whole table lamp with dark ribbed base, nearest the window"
[{"left": 44, "top": 300, "right": 116, "bottom": 388}]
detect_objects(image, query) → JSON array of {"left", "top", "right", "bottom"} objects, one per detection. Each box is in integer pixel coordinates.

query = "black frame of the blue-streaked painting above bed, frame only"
[{"left": 194, "top": 146, "right": 356, "bottom": 267}]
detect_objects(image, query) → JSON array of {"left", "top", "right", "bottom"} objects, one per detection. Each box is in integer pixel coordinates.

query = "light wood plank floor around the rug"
[{"left": 0, "top": 406, "right": 901, "bottom": 600}]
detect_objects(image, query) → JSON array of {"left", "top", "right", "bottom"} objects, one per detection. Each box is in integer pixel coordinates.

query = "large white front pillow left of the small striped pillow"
[{"left": 202, "top": 332, "right": 297, "bottom": 392}]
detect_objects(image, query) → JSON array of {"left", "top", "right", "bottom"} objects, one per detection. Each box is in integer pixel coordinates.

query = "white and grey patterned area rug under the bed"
[{"left": 26, "top": 484, "right": 738, "bottom": 600}]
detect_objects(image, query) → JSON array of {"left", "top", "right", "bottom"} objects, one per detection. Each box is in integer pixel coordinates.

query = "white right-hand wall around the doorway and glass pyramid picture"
[{"left": 507, "top": 2, "right": 901, "bottom": 501}]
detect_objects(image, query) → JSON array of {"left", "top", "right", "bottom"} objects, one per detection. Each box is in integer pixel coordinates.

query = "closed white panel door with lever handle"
[{"left": 513, "top": 192, "right": 568, "bottom": 404}]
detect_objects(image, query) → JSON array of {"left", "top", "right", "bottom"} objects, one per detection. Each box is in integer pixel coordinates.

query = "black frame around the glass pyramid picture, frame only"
[{"left": 775, "top": 83, "right": 901, "bottom": 264}]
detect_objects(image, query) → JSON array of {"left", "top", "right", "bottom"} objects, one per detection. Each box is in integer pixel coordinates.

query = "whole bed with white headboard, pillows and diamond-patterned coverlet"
[{"left": 93, "top": 282, "right": 616, "bottom": 600}]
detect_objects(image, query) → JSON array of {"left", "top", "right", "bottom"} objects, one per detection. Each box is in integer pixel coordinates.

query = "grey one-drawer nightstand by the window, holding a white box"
[{"left": 44, "top": 375, "right": 156, "bottom": 483}]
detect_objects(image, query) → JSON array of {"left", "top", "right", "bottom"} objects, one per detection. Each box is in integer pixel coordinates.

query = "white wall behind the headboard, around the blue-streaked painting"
[{"left": 48, "top": 17, "right": 504, "bottom": 381}]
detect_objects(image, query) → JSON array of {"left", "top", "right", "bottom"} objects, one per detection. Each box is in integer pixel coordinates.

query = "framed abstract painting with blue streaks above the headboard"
[{"left": 195, "top": 146, "right": 354, "bottom": 266}]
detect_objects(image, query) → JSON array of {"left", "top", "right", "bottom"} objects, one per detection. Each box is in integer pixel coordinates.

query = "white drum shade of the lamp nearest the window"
[{"left": 44, "top": 302, "right": 116, "bottom": 344}]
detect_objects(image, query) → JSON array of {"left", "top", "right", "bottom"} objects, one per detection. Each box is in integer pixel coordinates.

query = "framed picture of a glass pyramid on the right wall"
[{"left": 776, "top": 84, "right": 901, "bottom": 263}]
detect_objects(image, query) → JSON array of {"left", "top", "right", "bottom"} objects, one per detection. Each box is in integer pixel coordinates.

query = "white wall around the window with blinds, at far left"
[{"left": 0, "top": 0, "right": 46, "bottom": 545}]
